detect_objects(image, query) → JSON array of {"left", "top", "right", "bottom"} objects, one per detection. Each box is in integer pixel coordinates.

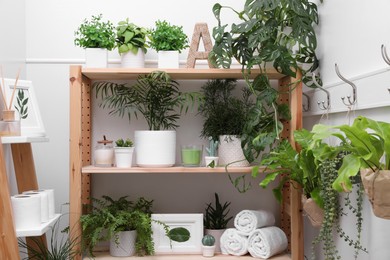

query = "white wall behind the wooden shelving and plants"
[{"left": 19, "top": 0, "right": 390, "bottom": 260}]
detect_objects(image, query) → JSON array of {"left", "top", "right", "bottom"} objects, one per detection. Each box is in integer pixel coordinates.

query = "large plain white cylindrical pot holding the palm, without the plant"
[{"left": 134, "top": 130, "right": 176, "bottom": 167}]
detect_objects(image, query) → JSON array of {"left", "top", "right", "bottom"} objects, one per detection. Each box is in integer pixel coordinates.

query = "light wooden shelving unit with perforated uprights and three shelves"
[{"left": 69, "top": 66, "right": 304, "bottom": 260}]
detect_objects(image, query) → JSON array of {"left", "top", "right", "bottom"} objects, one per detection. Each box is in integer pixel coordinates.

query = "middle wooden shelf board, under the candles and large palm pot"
[{"left": 82, "top": 166, "right": 262, "bottom": 174}]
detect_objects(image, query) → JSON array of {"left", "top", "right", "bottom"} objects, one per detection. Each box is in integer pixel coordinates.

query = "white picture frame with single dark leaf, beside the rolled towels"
[{"left": 152, "top": 214, "right": 203, "bottom": 254}]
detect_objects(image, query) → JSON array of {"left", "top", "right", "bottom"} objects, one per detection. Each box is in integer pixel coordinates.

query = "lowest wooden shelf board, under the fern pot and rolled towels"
[{"left": 84, "top": 252, "right": 291, "bottom": 260}]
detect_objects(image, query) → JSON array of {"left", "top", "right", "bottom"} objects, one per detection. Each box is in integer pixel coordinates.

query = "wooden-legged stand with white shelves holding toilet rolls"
[{"left": 0, "top": 136, "right": 51, "bottom": 260}]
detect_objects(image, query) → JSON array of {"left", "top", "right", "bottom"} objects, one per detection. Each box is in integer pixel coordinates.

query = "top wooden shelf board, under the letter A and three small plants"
[{"left": 82, "top": 68, "right": 284, "bottom": 80}]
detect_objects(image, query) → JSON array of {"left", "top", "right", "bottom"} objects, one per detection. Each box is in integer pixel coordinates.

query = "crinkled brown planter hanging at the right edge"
[{"left": 360, "top": 169, "right": 390, "bottom": 219}]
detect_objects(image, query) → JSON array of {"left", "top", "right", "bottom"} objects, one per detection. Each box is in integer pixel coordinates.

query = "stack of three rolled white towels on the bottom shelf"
[{"left": 221, "top": 210, "right": 288, "bottom": 259}]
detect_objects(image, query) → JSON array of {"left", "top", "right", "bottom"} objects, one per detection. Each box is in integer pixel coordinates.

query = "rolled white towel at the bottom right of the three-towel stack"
[{"left": 248, "top": 227, "right": 288, "bottom": 259}]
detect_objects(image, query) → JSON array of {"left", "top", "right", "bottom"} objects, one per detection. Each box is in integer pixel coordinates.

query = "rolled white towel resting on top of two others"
[{"left": 234, "top": 210, "right": 275, "bottom": 235}]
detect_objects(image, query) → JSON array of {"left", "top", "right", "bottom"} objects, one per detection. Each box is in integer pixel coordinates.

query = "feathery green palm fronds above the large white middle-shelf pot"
[{"left": 93, "top": 71, "right": 200, "bottom": 130}]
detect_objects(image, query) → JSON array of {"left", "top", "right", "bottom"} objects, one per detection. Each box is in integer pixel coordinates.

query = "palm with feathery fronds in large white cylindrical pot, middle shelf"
[{"left": 93, "top": 71, "right": 197, "bottom": 167}]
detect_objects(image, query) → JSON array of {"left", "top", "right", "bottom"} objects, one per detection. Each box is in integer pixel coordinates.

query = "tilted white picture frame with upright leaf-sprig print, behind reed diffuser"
[{"left": 3, "top": 79, "right": 46, "bottom": 137}]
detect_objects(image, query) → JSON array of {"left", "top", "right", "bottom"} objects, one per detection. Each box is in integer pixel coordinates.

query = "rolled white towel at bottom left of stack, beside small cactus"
[{"left": 220, "top": 228, "right": 248, "bottom": 256}]
